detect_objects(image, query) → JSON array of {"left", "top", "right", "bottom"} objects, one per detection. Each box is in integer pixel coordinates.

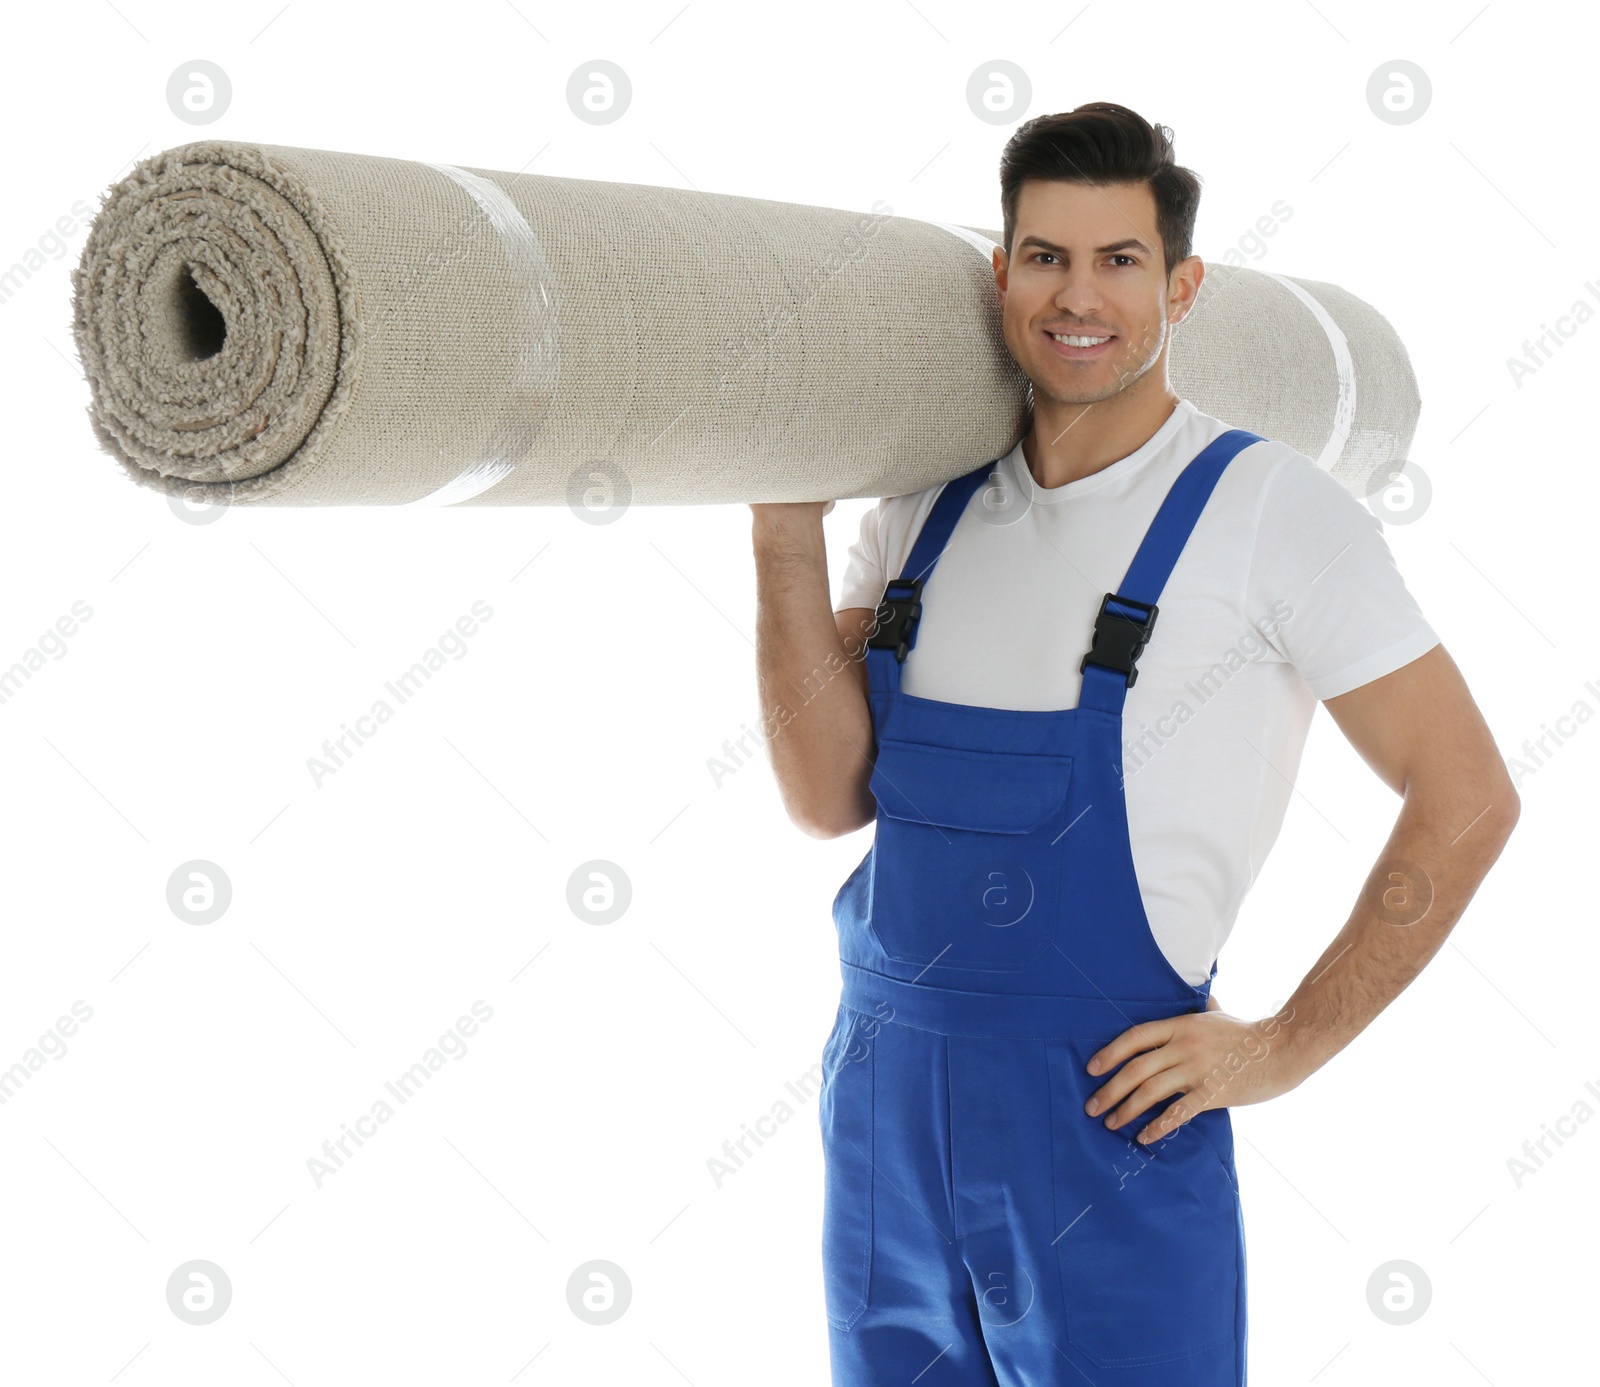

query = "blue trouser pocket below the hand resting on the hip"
[{"left": 1046, "top": 1037, "right": 1243, "bottom": 1368}]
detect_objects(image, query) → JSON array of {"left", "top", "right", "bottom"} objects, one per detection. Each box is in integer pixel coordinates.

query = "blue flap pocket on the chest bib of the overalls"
[{"left": 867, "top": 737, "right": 1072, "bottom": 973}]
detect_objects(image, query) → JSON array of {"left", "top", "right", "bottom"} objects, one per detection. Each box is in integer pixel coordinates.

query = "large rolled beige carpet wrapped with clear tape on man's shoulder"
[{"left": 72, "top": 141, "right": 1419, "bottom": 506}]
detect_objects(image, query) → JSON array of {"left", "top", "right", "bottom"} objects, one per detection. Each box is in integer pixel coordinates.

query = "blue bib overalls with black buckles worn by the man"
[{"left": 821, "top": 429, "right": 1258, "bottom": 1387}]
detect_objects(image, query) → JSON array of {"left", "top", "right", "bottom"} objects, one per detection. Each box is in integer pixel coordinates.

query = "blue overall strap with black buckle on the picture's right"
[{"left": 1078, "top": 429, "right": 1262, "bottom": 717}]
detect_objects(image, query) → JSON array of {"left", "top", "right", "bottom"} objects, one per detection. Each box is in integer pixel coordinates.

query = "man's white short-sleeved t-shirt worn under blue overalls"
[{"left": 837, "top": 400, "right": 1438, "bottom": 985}]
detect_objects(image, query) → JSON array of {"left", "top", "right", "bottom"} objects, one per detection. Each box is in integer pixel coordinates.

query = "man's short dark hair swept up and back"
[{"left": 1000, "top": 101, "right": 1200, "bottom": 275}]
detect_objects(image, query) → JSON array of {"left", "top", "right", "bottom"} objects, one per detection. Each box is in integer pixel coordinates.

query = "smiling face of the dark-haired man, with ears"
[{"left": 994, "top": 179, "right": 1205, "bottom": 405}]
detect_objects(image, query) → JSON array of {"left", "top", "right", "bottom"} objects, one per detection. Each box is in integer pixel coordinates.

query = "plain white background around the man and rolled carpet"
[{"left": 0, "top": 0, "right": 1600, "bottom": 1387}]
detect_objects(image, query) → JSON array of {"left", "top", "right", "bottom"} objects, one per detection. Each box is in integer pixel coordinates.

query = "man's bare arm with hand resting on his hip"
[{"left": 1088, "top": 645, "right": 1520, "bottom": 1141}]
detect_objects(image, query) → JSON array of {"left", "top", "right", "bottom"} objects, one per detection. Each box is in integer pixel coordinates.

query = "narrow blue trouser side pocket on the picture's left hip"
[{"left": 819, "top": 1006, "right": 874, "bottom": 1329}]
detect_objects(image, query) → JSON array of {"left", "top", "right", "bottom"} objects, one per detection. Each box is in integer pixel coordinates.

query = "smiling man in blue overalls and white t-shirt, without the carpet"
[{"left": 754, "top": 102, "right": 1518, "bottom": 1387}]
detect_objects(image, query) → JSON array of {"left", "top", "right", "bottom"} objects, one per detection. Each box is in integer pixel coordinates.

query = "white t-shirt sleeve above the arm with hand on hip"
[{"left": 1246, "top": 451, "right": 1438, "bottom": 701}]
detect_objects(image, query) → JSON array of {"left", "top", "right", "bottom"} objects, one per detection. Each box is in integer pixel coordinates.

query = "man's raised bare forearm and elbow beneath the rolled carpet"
[{"left": 750, "top": 501, "right": 877, "bottom": 838}]
